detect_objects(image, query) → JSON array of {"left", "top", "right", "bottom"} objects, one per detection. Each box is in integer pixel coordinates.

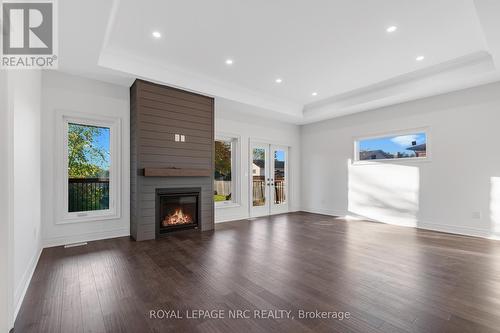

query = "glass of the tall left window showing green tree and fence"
[{"left": 67, "top": 123, "right": 111, "bottom": 213}]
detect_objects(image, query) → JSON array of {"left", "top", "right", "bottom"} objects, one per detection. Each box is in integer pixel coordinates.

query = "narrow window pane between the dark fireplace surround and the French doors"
[{"left": 214, "top": 137, "right": 238, "bottom": 205}]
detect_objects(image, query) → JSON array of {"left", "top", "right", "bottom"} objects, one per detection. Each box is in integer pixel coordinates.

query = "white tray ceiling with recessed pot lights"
[{"left": 56, "top": 0, "right": 500, "bottom": 123}]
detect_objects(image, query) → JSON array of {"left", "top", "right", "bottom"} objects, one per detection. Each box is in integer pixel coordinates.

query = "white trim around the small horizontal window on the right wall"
[{"left": 352, "top": 127, "right": 432, "bottom": 165}]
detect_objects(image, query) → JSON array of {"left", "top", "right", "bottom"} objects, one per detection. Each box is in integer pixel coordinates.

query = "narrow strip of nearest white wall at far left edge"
[{"left": 0, "top": 70, "right": 12, "bottom": 333}]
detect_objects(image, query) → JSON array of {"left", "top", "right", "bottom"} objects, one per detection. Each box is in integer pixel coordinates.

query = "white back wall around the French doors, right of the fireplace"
[{"left": 215, "top": 98, "right": 300, "bottom": 222}]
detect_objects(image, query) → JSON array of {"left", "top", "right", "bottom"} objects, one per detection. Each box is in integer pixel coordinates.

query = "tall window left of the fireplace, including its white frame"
[{"left": 58, "top": 116, "right": 121, "bottom": 223}]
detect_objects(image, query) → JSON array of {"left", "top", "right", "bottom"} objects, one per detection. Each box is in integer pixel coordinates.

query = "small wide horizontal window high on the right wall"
[{"left": 355, "top": 131, "right": 428, "bottom": 161}]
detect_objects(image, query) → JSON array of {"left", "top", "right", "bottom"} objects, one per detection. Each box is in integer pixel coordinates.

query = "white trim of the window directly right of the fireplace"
[{"left": 214, "top": 133, "right": 241, "bottom": 209}]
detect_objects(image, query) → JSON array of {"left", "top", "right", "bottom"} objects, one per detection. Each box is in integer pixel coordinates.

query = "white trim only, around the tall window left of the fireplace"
[{"left": 55, "top": 111, "right": 122, "bottom": 224}]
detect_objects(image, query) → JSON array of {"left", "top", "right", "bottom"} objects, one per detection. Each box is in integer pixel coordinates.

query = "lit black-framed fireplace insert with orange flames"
[{"left": 156, "top": 187, "right": 201, "bottom": 237}]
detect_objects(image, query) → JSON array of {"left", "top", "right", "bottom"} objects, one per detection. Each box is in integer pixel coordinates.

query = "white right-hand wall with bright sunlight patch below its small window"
[{"left": 301, "top": 84, "right": 500, "bottom": 237}]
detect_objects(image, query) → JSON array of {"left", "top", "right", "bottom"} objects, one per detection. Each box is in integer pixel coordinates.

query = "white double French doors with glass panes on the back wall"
[{"left": 250, "top": 143, "right": 289, "bottom": 217}]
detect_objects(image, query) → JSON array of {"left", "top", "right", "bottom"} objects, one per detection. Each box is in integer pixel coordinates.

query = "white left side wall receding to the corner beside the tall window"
[{"left": 6, "top": 70, "right": 41, "bottom": 324}]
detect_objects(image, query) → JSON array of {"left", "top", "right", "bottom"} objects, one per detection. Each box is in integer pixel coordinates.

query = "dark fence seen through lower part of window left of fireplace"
[{"left": 68, "top": 178, "right": 109, "bottom": 212}]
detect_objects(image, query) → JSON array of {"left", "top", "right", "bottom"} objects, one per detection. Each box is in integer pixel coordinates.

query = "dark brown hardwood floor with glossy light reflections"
[{"left": 15, "top": 213, "right": 500, "bottom": 333}]
